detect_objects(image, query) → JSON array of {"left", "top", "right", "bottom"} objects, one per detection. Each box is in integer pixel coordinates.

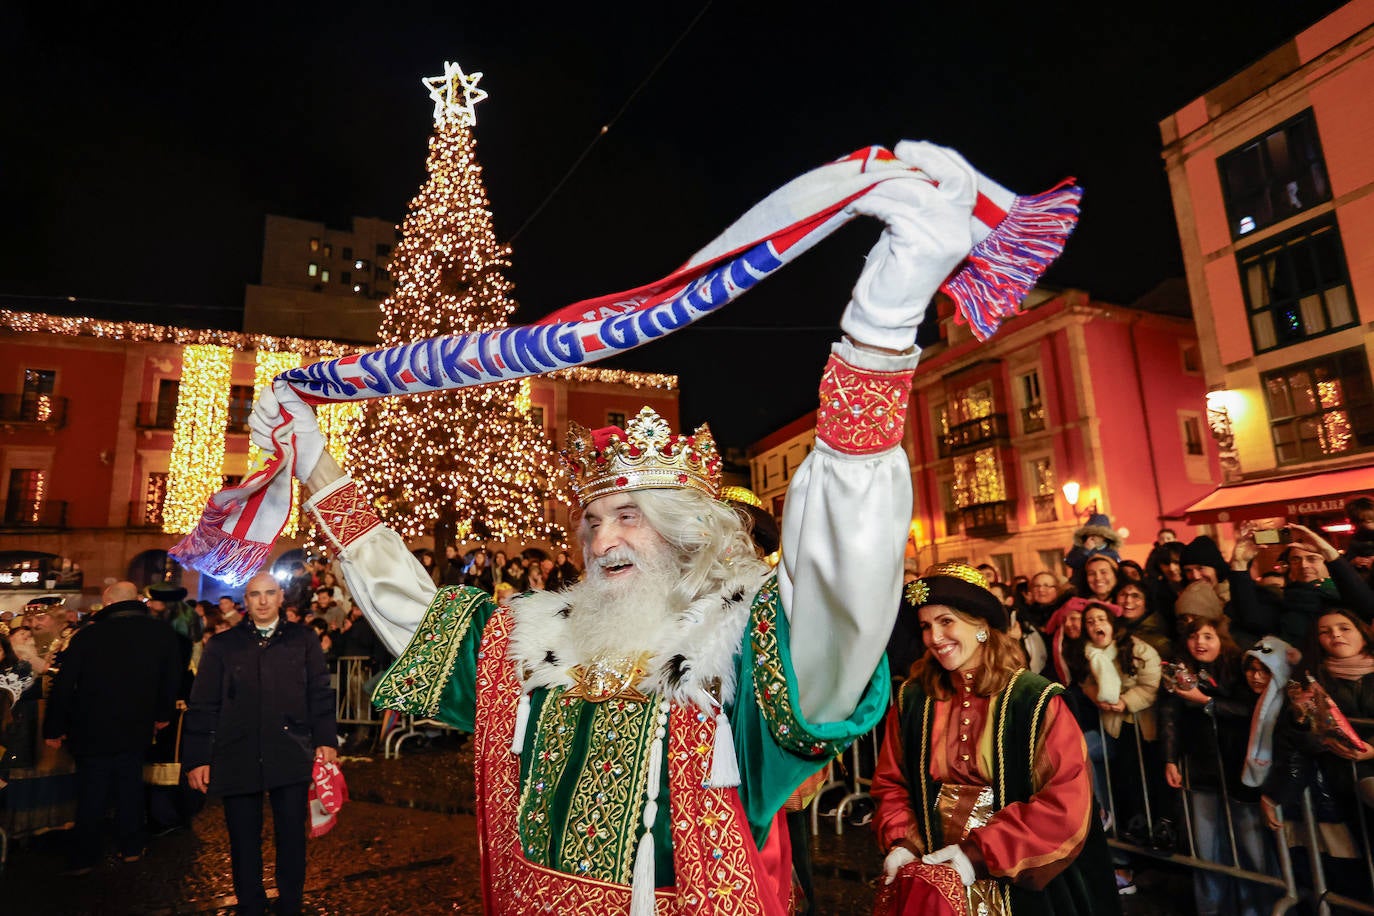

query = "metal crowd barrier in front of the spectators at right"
[{"left": 1098, "top": 714, "right": 1374, "bottom": 916}]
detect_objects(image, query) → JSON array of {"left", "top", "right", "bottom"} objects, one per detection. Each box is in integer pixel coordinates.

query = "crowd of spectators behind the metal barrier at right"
[{"left": 889, "top": 497, "right": 1374, "bottom": 916}]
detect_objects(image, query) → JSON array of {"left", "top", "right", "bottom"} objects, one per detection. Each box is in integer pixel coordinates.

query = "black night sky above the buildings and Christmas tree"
[{"left": 0, "top": 0, "right": 1341, "bottom": 446}]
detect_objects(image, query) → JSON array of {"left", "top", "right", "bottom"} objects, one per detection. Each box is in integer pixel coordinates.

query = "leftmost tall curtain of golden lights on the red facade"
[{"left": 162, "top": 343, "right": 234, "bottom": 534}]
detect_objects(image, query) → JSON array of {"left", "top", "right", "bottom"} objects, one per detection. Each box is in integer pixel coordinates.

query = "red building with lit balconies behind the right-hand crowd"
[{"left": 750, "top": 290, "right": 1220, "bottom": 581}]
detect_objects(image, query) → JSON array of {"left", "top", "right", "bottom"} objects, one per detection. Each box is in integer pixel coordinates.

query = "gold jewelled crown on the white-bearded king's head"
[{"left": 563, "top": 407, "right": 720, "bottom": 505}]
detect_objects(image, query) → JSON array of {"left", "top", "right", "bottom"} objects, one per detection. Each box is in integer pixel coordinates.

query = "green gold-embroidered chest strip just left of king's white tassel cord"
[{"left": 559, "top": 699, "right": 658, "bottom": 884}]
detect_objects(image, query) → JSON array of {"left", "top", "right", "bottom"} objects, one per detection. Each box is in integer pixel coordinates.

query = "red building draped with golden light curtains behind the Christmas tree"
[{"left": 0, "top": 309, "right": 679, "bottom": 607}]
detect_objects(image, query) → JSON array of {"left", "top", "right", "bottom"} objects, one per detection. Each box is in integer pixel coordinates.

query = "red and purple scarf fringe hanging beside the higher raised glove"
[{"left": 941, "top": 179, "right": 1083, "bottom": 341}]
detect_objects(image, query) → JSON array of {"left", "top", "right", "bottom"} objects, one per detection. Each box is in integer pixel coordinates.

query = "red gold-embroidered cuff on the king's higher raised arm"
[{"left": 816, "top": 356, "right": 914, "bottom": 455}]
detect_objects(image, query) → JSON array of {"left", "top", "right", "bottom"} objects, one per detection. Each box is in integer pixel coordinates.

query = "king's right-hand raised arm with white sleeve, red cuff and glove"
[{"left": 778, "top": 143, "right": 976, "bottom": 722}]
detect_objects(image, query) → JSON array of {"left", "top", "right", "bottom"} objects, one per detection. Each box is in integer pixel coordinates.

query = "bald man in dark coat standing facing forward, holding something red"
[{"left": 181, "top": 573, "right": 338, "bottom": 913}]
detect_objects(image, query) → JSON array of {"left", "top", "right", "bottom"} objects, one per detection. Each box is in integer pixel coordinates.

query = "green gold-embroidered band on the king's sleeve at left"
[{"left": 372, "top": 586, "right": 491, "bottom": 715}]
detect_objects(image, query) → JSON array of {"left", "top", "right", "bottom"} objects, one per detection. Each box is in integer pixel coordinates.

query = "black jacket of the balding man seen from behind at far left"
[{"left": 43, "top": 600, "right": 183, "bottom": 757}]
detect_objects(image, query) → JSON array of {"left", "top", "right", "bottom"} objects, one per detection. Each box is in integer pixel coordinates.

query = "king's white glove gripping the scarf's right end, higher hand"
[{"left": 840, "top": 140, "right": 978, "bottom": 350}]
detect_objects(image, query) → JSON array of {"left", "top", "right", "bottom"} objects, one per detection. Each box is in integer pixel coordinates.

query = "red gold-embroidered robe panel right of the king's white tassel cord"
[{"left": 668, "top": 706, "right": 769, "bottom": 916}]
